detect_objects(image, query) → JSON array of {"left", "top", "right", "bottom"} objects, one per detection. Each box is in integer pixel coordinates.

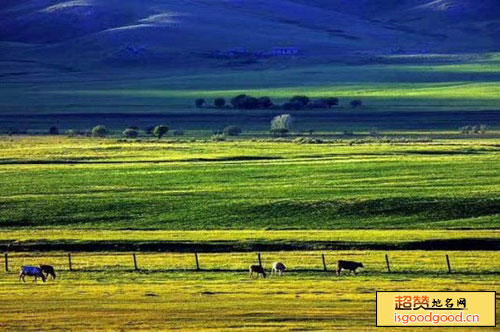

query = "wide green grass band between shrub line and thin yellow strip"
[{"left": 0, "top": 137, "right": 500, "bottom": 230}]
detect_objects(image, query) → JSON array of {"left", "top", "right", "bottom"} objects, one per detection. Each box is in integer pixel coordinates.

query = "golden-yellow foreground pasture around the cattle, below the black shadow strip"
[{"left": 0, "top": 251, "right": 500, "bottom": 331}]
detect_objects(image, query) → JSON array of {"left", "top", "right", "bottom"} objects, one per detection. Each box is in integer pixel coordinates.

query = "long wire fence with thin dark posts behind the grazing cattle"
[{"left": 3, "top": 251, "right": 500, "bottom": 274}]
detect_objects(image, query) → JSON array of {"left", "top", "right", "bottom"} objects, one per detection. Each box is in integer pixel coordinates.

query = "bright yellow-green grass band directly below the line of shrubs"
[{"left": 0, "top": 132, "right": 500, "bottom": 164}]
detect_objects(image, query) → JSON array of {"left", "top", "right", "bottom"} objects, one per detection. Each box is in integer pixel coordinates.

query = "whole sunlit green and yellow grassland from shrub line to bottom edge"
[{"left": 0, "top": 133, "right": 500, "bottom": 331}]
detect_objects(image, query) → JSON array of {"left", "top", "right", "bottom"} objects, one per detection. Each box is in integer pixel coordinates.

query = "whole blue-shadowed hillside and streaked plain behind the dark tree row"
[{"left": 0, "top": 0, "right": 500, "bottom": 119}]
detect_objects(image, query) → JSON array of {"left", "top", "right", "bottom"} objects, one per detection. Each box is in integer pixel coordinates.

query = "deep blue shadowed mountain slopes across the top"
[{"left": 0, "top": 0, "right": 500, "bottom": 68}]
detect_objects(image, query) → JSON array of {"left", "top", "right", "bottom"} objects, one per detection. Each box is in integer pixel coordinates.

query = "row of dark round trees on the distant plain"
[{"left": 195, "top": 94, "right": 363, "bottom": 110}]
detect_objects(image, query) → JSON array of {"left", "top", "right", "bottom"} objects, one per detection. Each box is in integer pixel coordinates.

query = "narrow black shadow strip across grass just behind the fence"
[{"left": 0, "top": 238, "right": 500, "bottom": 253}]
